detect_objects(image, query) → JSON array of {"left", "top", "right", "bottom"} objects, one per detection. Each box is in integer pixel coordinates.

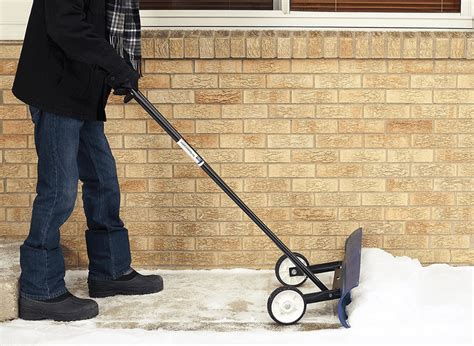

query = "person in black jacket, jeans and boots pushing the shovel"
[{"left": 13, "top": 0, "right": 163, "bottom": 321}]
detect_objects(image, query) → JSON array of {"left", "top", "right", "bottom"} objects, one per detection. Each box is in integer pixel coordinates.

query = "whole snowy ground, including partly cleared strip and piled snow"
[{"left": 0, "top": 249, "right": 474, "bottom": 345}]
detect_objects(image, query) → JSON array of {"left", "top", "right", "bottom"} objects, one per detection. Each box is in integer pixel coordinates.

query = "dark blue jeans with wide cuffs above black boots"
[{"left": 20, "top": 107, "right": 131, "bottom": 300}]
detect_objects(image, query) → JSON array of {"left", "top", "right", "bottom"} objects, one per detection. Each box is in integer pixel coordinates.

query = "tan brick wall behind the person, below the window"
[{"left": 0, "top": 31, "right": 474, "bottom": 268}]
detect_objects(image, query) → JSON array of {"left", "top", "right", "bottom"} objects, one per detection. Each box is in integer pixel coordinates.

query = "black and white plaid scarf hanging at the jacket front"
[{"left": 107, "top": 0, "right": 142, "bottom": 75}]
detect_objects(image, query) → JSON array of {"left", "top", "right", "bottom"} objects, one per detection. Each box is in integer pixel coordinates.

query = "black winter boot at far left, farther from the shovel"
[{"left": 18, "top": 292, "right": 99, "bottom": 321}]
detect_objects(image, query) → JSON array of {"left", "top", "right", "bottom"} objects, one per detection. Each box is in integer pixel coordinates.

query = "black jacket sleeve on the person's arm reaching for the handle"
[{"left": 45, "top": 0, "right": 130, "bottom": 75}]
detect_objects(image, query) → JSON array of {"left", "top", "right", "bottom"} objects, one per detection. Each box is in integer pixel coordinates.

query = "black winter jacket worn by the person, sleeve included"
[{"left": 13, "top": 0, "right": 130, "bottom": 121}]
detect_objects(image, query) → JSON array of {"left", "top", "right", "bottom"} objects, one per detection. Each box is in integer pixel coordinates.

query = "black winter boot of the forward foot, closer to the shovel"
[{"left": 87, "top": 269, "right": 163, "bottom": 298}]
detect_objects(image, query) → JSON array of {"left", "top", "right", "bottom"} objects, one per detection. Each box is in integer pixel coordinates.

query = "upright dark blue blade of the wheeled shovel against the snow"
[{"left": 337, "top": 228, "right": 362, "bottom": 328}]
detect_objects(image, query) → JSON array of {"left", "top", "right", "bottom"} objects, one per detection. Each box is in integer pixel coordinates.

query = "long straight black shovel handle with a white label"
[{"left": 131, "top": 89, "right": 328, "bottom": 291}]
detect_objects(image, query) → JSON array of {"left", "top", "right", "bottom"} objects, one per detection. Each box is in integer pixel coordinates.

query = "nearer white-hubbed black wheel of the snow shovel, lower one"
[{"left": 267, "top": 287, "right": 306, "bottom": 325}]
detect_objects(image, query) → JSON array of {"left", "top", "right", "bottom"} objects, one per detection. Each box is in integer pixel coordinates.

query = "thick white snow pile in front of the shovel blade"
[{"left": 347, "top": 249, "right": 474, "bottom": 342}]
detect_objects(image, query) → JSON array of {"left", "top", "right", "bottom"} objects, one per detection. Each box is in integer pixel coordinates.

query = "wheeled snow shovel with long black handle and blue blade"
[{"left": 126, "top": 90, "right": 362, "bottom": 328}]
